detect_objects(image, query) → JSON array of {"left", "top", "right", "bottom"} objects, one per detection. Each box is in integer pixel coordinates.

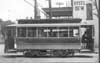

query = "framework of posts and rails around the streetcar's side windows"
[{"left": 16, "top": 26, "right": 80, "bottom": 38}]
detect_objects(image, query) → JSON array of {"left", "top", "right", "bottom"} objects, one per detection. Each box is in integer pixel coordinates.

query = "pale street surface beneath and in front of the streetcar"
[{"left": 0, "top": 44, "right": 99, "bottom": 63}]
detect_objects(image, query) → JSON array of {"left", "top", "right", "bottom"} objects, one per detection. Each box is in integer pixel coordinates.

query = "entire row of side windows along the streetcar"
[{"left": 17, "top": 27, "right": 79, "bottom": 38}]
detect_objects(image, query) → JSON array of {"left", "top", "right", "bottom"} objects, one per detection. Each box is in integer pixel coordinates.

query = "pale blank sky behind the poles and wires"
[{"left": 0, "top": 0, "right": 70, "bottom": 21}]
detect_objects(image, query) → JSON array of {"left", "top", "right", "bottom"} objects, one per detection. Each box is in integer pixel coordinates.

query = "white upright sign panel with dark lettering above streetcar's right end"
[{"left": 73, "top": 0, "right": 86, "bottom": 19}]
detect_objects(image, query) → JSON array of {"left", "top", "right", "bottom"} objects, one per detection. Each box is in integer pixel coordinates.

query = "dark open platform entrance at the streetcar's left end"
[{"left": 5, "top": 27, "right": 14, "bottom": 52}]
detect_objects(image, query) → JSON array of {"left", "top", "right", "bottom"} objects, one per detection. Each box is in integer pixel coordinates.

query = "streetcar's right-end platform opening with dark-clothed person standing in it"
[{"left": 82, "top": 25, "right": 94, "bottom": 51}]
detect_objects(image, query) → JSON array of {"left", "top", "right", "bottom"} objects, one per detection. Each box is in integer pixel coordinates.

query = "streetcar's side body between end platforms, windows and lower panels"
[{"left": 16, "top": 24, "right": 80, "bottom": 49}]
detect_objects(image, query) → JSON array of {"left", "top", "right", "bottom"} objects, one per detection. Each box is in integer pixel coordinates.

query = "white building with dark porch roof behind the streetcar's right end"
[{"left": 43, "top": 0, "right": 99, "bottom": 48}]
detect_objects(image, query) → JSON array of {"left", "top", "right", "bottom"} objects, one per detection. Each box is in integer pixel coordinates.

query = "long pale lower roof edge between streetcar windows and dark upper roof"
[{"left": 8, "top": 23, "right": 80, "bottom": 27}]
